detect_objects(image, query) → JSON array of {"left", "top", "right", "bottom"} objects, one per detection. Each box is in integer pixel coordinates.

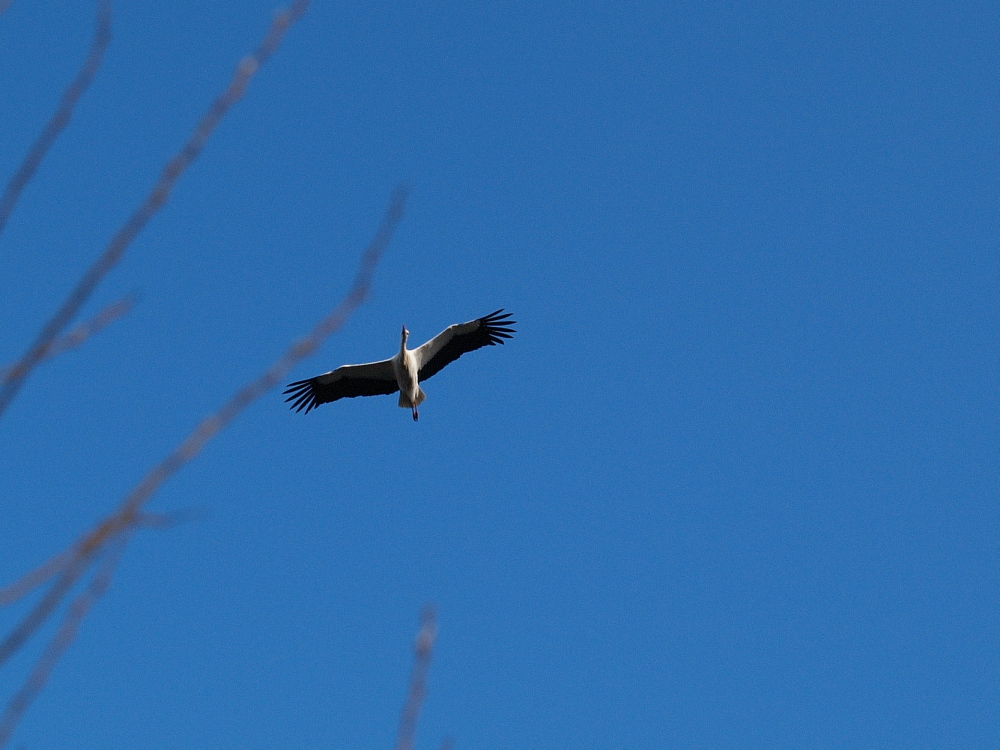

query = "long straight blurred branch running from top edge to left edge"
[{"left": 0, "top": 0, "right": 309, "bottom": 424}]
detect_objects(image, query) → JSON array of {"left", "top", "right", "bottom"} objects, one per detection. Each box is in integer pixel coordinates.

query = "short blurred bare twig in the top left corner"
[{"left": 0, "top": 0, "right": 111, "bottom": 241}]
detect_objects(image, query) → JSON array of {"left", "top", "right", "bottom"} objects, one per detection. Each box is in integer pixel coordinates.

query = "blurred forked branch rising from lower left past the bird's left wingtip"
[{"left": 0, "top": 187, "right": 407, "bottom": 747}]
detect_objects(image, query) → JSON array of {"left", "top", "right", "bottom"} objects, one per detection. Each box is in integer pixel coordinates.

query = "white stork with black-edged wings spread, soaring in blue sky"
[{"left": 285, "top": 308, "right": 517, "bottom": 422}]
